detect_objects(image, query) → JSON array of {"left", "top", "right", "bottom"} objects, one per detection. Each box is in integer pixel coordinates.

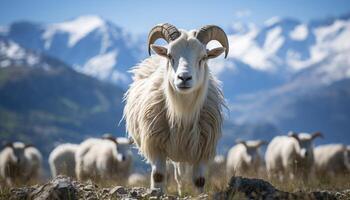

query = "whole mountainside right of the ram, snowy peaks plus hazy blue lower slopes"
[{"left": 219, "top": 16, "right": 350, "bottom": 143}]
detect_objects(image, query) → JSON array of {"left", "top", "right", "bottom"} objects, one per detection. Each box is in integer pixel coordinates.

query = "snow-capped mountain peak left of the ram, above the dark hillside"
[{"left": 0, "top": 16, "right": 138, "bottom": 86}]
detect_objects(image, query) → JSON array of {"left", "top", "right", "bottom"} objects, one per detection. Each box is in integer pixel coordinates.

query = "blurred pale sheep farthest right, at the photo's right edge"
[{"left": 314, "top": 144, "right": 350, "bottom": 176}]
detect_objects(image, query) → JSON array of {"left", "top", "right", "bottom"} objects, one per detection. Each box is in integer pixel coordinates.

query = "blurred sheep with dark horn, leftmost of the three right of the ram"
[{"left": 226, "top": 140, "right": 267, "bottom": 177}]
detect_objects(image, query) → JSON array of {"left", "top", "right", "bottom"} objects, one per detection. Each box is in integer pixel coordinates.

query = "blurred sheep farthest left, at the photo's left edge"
[{"left": 0, "top": 142, "right": 42, "bottom": 186}]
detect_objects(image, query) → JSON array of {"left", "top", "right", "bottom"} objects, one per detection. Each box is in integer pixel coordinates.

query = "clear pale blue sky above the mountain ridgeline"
[{"left": 0, "top": 0, "right": 350, "bottom": 33}]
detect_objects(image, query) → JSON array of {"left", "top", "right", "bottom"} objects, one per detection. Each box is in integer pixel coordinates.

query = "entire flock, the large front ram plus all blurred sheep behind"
[{"left": 0, "top": 24, "right": 350, "bottom": 195}]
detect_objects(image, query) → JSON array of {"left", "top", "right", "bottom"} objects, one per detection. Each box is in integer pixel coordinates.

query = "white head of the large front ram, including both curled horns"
[{"left": 148, "top": 24, "right": 229, "bottom": 93}]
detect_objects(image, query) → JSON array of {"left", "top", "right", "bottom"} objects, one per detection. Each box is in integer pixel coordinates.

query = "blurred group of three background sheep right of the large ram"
[{"left": 226, "top": 132, "right": 350, "bottom": 181}]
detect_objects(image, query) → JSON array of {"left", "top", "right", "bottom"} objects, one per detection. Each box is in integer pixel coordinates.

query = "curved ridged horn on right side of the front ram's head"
[{"left": 197, "top": 25, "right": 229, "bottom": 58}]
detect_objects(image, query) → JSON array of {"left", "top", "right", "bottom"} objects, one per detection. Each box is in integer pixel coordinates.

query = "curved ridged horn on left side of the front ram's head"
[{"left": 147, "top": 23, "right": 181, "bottom": 55}]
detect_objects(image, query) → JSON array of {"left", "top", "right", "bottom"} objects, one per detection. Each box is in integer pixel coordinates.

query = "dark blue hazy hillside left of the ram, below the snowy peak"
[{"left": 0, "top": 41, "right": 125, "bottom": 168}]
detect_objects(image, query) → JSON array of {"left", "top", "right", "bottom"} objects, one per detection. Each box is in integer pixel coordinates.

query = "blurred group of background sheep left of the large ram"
[{"left": 0, "top": 134, "right": 133, "bottom": 186}]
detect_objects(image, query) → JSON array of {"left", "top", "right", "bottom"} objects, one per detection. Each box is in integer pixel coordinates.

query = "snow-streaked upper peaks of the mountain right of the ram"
[{"left": 212, "top": 16, "right": 350, "bottom": 101}]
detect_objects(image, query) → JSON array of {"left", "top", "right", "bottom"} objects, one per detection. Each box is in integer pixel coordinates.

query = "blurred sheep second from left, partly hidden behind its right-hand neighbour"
[{"left": 49, "top": 143, "right": 79, "bottom": 178}]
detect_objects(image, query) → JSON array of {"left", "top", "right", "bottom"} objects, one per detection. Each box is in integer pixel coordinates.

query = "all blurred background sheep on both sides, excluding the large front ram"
[{"left": 0, "top": 132, "right": 350, "bottom": 186}]
